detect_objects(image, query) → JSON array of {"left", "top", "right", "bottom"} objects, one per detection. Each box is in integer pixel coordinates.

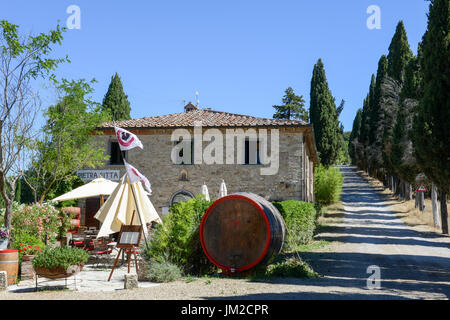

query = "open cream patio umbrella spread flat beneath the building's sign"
[{"left": 52, "top": 178, "right": 118, "bottom": 205}]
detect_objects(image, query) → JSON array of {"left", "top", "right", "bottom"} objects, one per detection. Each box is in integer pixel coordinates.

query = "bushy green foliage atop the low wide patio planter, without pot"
[{"left": 33, "top": 247, "right": 89, "bottom": 268}]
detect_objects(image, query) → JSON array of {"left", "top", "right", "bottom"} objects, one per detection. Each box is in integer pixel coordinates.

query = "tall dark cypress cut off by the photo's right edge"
[{"left": 412, "top": 0, "right": 450, "bottom": 234}]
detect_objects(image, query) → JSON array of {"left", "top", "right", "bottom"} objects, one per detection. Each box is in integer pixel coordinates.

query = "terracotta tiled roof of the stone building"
[{"left": 101, "top": 109, "right": 308, "bottom": 128}]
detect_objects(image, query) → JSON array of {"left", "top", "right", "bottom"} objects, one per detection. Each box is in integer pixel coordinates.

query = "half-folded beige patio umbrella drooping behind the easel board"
[{"left": 94, "top": 174, "right": 162, "bottom": 238}]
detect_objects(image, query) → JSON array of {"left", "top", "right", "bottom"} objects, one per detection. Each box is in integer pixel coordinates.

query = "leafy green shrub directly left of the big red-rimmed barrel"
[{"left": 141, "top": 197, "right": 215, "bottom": 275}]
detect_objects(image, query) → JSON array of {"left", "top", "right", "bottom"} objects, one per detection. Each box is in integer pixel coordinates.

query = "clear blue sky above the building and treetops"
[{"left": 0, "top": 0, "right": 429, "bottom": 131}]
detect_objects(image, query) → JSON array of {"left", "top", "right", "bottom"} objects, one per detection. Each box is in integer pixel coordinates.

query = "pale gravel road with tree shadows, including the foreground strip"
[{"left": 0, "top": 166, "right": 450, "bottom": 300}]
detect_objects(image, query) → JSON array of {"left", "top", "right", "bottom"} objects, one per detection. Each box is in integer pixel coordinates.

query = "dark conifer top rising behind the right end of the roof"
[{"left": 273, "top": 87, "right": 308, "bottom": 122}]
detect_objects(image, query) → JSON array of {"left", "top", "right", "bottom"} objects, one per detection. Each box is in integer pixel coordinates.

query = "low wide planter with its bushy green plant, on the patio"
[{"left": 32, "top": 247, "right": 89, "bottom": 279}]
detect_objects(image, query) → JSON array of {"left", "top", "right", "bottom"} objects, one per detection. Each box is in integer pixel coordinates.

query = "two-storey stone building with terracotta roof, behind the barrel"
[{"left": 78, "top": 103, "right": 318, "bottom": 222}]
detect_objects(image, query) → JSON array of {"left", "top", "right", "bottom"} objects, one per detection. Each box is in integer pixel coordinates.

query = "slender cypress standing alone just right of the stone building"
[{"left": 309, "top": 59, "right": 340, "bottom": 166}]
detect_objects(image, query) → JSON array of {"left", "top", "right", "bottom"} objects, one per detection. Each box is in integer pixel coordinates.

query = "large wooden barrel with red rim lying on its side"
[{"left": 200, "top": 193, "right": 286, "bottom": 274}]
